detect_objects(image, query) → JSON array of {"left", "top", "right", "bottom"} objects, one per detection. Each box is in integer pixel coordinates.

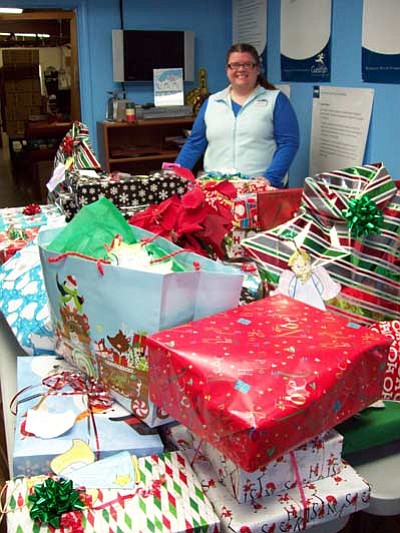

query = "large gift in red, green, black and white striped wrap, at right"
[{"left": 241, "top": 163, "right": 400, "bottom": 325}]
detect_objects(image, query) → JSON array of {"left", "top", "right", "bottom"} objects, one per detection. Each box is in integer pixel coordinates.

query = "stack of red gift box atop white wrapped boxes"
[{"left": 144, "top": 295, "right": 390, "bottom": 533}]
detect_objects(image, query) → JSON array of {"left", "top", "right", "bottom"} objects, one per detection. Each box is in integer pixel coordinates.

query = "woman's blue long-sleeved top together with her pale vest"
[{"left": 176, "top": 87, "right": 299, "bottom": 188}]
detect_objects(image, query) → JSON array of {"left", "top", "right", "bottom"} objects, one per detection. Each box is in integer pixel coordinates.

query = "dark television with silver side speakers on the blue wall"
[{"left": 113, "top": 30, "right": 194, "bottom": 81}]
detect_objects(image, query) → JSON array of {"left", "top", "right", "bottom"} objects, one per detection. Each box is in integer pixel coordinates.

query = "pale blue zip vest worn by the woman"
[{"left": 204, "top": 86, "right": 279, "bottom": 177}]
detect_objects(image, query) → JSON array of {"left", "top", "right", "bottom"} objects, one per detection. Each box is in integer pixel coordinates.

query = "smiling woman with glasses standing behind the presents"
[{"left": 176, "top": 43, "right": 299, "bottom": 188}]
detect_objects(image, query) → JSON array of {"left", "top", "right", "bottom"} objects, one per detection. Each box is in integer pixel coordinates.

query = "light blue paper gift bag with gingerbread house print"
[{"left": 39, "top": 220, "right": 243, "bottom": 426}]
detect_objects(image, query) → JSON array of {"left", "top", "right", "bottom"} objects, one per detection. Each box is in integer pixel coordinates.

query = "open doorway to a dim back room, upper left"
[{"left": 0, "top": 8, "right": 81, "bottom": 207}]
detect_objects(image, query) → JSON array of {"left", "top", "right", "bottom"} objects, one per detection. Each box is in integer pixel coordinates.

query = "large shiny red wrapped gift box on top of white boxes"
[{"left": 148, "top": 295, "right": 390, "bottom": 471}]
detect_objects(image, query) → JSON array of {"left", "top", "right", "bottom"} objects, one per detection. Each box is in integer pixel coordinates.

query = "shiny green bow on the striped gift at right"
[{"left": 342, "top": 194, "right": 383, "bottom": 238}]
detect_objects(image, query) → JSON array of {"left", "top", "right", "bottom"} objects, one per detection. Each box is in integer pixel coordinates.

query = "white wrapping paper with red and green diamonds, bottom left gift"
[{"left": 6, "top": 452, "right": 219, "bottom": 533}]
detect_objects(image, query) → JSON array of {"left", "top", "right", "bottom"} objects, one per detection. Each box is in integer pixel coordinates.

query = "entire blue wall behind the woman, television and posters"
[{"left": 0, "top": 0, "right": 400, "bottom": 186}]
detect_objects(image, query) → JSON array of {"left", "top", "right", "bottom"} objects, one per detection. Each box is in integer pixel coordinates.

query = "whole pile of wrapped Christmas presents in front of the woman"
[{"left": 0, "top": 159, "right": 399, "bottom": 533}]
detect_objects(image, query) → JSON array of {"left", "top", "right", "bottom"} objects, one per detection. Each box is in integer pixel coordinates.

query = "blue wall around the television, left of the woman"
[{"left": 83, "top": 0, "right": 231, "bottom": 139}]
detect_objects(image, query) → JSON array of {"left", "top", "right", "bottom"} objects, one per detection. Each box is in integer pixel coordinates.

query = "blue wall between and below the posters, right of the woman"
[{"left": 267, "top": 0, "right": 400, "bottom": 187}]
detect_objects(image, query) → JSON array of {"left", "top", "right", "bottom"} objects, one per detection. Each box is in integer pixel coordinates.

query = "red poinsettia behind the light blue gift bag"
[{"left": 129, "top": 182, "right": 236, "bottom": 258}]
